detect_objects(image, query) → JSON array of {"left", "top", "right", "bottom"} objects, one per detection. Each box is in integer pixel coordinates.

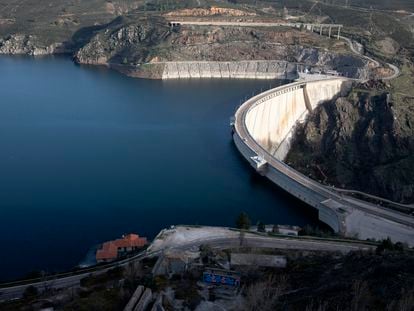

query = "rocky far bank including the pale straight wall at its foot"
[{"left": 0, "top": 17, "right": 372, "bottom": 79}]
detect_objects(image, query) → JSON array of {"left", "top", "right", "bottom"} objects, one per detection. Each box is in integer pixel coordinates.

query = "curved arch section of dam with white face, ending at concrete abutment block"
[{"left": 233, "top": 78, "right": 352, "bottom": 234}]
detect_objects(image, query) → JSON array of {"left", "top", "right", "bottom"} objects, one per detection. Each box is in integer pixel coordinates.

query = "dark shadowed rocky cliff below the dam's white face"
[{"left": 286, "top": 82, "right": 414, "bottom": 203}]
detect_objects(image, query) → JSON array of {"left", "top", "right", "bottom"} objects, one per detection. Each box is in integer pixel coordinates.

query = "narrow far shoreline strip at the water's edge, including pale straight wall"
[{"left": 0, "top": 51, "right": 366, "bottom": 80}]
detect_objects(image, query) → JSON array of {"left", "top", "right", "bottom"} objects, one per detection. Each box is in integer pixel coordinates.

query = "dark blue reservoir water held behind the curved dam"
[{"left": 0, "top": 57, "right": 316, "bottom": 280}]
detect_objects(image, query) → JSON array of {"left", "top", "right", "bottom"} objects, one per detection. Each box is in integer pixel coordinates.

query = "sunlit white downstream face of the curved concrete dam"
[{"left": 246, "top": 79, "right": 351, "bottom": 161}]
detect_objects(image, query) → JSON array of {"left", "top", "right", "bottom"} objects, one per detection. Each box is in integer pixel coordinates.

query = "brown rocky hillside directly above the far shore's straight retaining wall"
[{"left": 75, "top": 17, "right": 369, "bottom": 78}]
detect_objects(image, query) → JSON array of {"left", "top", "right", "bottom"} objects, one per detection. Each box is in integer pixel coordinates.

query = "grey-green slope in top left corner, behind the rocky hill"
[{"left": 0, "top": 0, "right": 143, "bottom": 44}]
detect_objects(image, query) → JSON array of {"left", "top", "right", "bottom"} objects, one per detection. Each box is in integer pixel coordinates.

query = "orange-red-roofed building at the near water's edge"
[{"left": 96, "top": 233, "right": 148, "bottom": 263}]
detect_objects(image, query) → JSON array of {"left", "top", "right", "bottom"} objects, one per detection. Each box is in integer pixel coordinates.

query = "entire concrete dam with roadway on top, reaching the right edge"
[{"left": 232, "top": 78, "right": 414, "bottom": 246}]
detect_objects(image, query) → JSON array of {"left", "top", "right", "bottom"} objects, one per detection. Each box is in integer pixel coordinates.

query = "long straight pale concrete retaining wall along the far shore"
[{"left": 162, "top": 61, "right": 298, "bottom": 79}]
